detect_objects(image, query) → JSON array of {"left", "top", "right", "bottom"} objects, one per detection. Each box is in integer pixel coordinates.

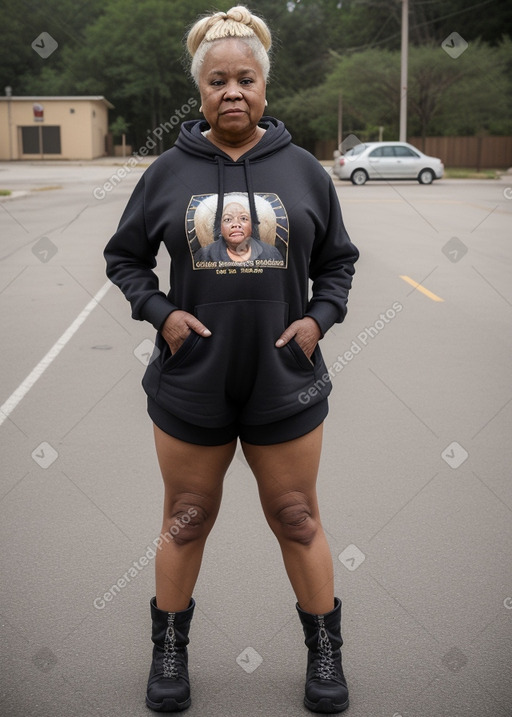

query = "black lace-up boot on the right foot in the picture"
[{"left": 297, "top": 598, "right": 348, "bottom": 714}]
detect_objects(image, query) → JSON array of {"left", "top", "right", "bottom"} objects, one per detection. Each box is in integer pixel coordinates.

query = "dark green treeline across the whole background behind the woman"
[{"left": 0, "top": 0, "right": 512, "bottom": 151}]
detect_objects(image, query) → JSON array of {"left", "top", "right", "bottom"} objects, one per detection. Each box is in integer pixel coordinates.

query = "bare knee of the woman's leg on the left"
[{"left": 162, "top": 494, "right": 212, "bottom": 546}]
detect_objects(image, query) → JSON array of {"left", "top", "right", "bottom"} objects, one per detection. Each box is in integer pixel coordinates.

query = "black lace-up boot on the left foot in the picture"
[{"left": 146, "top": 598, "right": 195, "bottom": 712}]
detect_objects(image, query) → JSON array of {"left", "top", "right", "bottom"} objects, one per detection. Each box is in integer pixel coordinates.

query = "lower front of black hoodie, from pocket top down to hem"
[{"left": 143, "top": 300, "right": 330, "bottom": 427}]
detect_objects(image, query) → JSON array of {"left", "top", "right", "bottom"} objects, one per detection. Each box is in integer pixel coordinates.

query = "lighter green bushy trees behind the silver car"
[{"left": 277, "top": 40, "right": 512, "bottom": 148}]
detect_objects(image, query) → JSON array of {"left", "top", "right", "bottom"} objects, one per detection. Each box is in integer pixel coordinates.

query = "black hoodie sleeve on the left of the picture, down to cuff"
[{"left": 104, "top": 176, "right": 178, "bottom": 331}]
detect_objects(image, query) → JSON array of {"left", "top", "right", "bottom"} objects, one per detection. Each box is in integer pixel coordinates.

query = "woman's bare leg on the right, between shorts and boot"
[{"left": 242, "top": 426, "right": 334, "bottom": 615}]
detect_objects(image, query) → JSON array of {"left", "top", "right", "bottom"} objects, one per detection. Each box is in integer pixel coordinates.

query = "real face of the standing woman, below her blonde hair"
[{"left": 199, "top": 38, "right": 265, "bottom": 142}]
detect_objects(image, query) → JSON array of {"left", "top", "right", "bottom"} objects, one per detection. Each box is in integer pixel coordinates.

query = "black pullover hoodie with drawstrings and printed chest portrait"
[{"left": 105, "top": 117, "right": 358, "bottom": 427}]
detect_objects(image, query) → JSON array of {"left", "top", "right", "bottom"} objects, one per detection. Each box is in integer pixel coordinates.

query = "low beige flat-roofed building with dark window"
[{"left": 0, "top": 96, "right": 113, "bottom": 160}]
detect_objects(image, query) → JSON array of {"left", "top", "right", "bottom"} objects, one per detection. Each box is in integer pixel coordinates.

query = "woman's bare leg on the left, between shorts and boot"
[{"left": 154, "top": 426, "right": 236, "bottom": 612}]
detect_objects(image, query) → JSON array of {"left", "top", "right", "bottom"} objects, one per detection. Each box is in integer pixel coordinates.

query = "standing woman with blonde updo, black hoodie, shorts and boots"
[{"left": 105, "top": 6, "right": 358, "bottom": 713}]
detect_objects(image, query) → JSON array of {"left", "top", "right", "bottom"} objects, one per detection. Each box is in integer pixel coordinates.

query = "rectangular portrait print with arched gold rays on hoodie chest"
[{"left": 186, "top": 192, "right": 289, "bottom": 274}]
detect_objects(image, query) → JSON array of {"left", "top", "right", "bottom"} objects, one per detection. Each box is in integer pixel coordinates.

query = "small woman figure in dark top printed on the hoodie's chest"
[{"left": 194, "top": 200, "right": 284, "bottom": 264}]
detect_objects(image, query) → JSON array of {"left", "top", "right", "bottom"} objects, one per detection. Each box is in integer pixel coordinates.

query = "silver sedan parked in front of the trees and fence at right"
[{"left": 333, "top": 142, "right": 444, "bottom": 184}]
